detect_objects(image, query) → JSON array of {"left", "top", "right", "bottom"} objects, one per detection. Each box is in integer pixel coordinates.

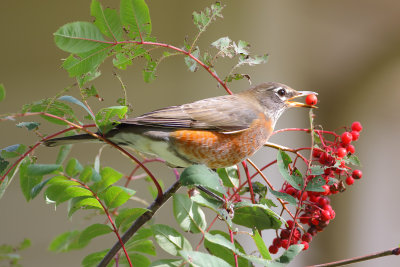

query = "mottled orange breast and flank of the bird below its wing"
[{"left": 170, "top": 115, "right": 273, "bottom": 168}]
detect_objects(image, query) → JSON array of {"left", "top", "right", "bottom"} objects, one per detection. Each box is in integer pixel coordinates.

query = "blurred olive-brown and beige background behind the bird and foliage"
[{"left": 0, "top": 0, "right": 400, "bottom": 267}]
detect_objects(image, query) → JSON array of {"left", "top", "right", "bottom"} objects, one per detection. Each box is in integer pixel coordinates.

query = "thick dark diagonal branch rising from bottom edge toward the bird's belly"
[{"left": 97, "top": 181, "right": 181, "bottom": 267}]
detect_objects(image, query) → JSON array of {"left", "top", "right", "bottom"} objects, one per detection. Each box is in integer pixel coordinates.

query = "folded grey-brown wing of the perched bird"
[{"left": 120, "top": 95, "right": 260, "bottom": 132}]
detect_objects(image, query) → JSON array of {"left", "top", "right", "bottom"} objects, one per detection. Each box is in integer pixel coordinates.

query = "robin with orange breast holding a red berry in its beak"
[{"left": 44, "top": 82, "right": 315, "bottom": 168}]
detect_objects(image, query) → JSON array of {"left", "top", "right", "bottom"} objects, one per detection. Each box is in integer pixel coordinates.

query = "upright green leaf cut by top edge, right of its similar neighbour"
[{"left": 120, "top": 0, "right": 151, "bottom": 39}]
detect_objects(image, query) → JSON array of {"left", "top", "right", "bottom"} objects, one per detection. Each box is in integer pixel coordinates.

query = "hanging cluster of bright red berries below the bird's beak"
[{"left": 269, "top": 122, "right": 362, "bottom": 254}]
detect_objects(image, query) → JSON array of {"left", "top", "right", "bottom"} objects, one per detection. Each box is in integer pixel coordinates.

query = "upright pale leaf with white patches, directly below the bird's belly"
[{"left": 173, "top": 194, "right": 207, "bottom": 233}]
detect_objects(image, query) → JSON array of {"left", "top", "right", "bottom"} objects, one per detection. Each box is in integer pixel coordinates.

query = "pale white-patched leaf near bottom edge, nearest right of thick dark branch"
[{"left": 151, "top": 224, "right": 192, "bottom": 256}]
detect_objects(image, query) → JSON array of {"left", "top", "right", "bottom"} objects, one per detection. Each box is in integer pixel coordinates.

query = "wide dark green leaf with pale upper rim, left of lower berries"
[{"left": 232, "top": 202, "right": 282, "bottom": 230}]
